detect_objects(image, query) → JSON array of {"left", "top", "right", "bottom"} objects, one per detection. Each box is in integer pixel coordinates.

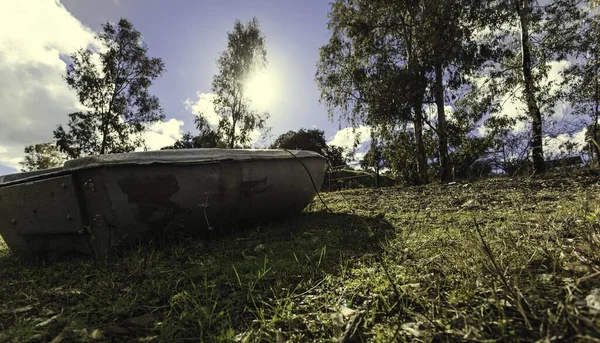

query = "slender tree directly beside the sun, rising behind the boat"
[{"left": 212, "top": 18, "right": 269, "bottom": 149}]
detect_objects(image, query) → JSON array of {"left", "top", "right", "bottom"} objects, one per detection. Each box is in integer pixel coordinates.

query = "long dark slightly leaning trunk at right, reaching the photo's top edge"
[{"left": 519, "top": 0, "right": 545, "bottom": 174}]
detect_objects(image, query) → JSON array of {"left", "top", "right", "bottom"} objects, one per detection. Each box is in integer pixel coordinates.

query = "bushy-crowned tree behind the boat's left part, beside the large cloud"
[{"left": 54, "top": 19, "right": 164, "bottom": 158}]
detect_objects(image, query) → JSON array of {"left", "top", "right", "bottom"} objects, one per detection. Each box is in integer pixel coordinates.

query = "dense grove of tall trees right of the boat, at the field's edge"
[{"left": 316, "top": 0, "right": 600, "bottom": 184}]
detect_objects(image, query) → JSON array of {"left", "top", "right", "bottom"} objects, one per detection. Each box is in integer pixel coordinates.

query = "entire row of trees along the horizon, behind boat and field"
[{"left": 18, "top": 0, "right": 600, "bottom": 184}]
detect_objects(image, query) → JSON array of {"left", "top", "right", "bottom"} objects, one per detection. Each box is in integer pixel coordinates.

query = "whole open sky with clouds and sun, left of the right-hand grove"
[{"left": 0, "top": 0, "right": 365, "bottom": 175}]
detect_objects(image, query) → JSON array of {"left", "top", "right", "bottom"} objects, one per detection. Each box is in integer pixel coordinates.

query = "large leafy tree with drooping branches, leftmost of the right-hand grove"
[{"left": 316, "top": 0, "right": 428, "bottom": 183}]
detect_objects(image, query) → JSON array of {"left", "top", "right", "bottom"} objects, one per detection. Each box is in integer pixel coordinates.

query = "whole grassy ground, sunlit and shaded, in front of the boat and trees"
[{"left": 0, "top": 171, "right": 600, "bottom": 343}]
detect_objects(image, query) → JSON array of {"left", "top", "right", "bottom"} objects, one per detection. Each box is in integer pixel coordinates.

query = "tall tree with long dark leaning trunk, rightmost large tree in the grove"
[{"left": 480, "top": 0, "right": 581, "bottom": 174}]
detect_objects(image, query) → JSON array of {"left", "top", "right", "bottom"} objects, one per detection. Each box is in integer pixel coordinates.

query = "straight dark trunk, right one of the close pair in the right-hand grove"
[{"left": 435, "top": 60, "right": 452, "bottom": 182}]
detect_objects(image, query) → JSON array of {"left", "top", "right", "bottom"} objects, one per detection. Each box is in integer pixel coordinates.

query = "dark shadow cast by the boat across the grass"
[{"left": 0, "top": 212, "right": 393, "bottom": 341}]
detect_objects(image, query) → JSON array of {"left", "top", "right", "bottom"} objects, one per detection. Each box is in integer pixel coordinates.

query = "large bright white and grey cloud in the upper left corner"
[{"left": 0, "top": 0, "right": 95, "bottom": 167}]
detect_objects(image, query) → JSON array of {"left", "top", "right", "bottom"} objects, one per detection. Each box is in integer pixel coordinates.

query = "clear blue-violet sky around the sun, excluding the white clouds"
[{"left": 63, "top": 0, "right": 335, "bottom": 134}]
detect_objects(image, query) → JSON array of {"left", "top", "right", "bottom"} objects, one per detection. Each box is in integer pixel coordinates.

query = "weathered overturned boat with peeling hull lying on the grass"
[{"left": 0, "top": 149, "right": 326, "bottom": 255}]
